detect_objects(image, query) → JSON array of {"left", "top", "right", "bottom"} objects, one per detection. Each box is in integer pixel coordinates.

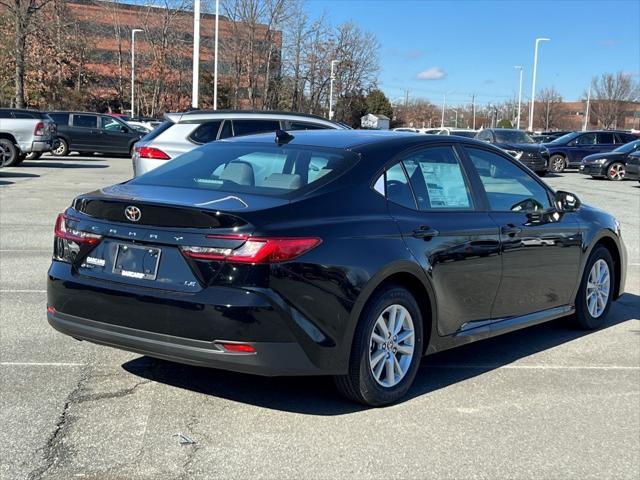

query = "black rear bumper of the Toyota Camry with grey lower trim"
[{"left": 47, "top": 261, "right": 336, "bottom": 376}]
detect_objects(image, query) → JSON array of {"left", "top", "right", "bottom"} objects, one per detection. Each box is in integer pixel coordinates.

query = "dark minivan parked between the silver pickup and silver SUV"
[{"left": 49, "top": 112, "right": 144, "bottom": 156}]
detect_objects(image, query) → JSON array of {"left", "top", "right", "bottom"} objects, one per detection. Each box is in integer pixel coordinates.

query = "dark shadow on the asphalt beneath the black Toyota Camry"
[{"left": 122, "top": 294, "right": 640, "bottom": 416}]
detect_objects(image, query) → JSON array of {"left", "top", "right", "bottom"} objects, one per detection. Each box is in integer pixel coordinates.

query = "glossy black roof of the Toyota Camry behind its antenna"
[{"left": 219, "top": 130, "right": 486, "bottom": 150}]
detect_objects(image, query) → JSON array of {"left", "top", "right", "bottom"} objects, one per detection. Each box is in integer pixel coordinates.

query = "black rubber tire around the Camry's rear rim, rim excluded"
[{"left": 334, "top": 285, "right": 424, "bottom": 407}]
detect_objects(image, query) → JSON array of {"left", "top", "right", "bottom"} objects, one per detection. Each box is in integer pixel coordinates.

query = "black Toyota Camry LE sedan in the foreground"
[{"left": 47, "top": 131, "right": 626, "bottom": 406}]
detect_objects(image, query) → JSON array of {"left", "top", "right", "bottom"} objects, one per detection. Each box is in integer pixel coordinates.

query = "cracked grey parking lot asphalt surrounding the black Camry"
[{"left": 0, "top": 156, "right": 640, "bottom": 480}]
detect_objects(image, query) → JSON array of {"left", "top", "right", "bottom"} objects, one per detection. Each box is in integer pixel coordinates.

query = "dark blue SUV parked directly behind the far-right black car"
[{"left": 545, "top": 130, "right": 638, "bottom": 173}]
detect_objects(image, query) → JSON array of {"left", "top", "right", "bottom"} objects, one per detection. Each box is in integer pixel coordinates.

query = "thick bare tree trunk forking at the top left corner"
[{"left": 0, "top": 0, "right": 51, "bottom": 108}]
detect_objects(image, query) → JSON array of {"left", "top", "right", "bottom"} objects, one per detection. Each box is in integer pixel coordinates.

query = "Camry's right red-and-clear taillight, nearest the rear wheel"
[{"left": 180, "top": 235, "right": 322, "bottom": 263}]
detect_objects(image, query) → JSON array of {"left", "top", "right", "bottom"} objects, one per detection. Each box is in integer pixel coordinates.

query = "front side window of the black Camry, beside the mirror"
[{"left": 465, "top": 147, "right": 551, "bottom": 212}]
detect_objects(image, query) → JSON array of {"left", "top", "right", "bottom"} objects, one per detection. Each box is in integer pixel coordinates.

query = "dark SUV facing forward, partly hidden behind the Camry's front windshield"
[{"left": 475, "top": 128, "right": 549, "bottom": 177}]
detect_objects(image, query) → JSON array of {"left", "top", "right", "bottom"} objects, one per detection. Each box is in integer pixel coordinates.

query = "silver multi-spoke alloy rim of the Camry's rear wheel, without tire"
[{"left": 369, "top": 304, "right": 415, "bottom": 388}]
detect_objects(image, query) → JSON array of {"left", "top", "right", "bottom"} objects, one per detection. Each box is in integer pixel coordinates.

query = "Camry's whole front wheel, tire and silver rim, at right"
[{"left": 575, "top": 246, "right": 615, "bottom": 330}]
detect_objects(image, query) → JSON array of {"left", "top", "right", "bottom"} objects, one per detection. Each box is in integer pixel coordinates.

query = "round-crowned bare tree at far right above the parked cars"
[{"left": 591, "top": 72, "right": 640, "bottom": 128}]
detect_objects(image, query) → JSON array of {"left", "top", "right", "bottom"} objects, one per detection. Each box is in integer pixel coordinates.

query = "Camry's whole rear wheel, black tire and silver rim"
[{"left": 335, "top": 286, "right": 423, "bottom": 407}]
